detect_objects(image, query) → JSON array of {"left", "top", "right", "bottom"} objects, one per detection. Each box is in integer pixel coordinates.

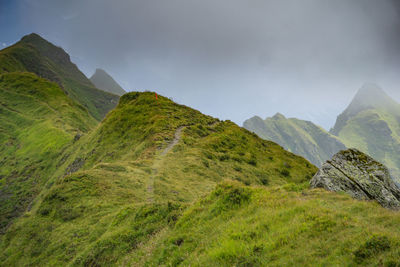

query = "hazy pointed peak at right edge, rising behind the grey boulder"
[{"left": 331, "top": 84, "right": 400, "bottom": 181}]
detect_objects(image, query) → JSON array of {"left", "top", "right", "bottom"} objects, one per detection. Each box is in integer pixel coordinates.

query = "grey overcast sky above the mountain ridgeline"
[{"left": 0, "top": 0, "right": 400, "bottom": 129}]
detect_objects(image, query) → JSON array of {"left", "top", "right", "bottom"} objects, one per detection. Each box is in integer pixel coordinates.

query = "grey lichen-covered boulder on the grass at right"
[{"left": 310, "top": 149, "right": 400, "bottom": 209}]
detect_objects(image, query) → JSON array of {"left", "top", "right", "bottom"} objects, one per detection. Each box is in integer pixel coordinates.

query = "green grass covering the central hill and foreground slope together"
[{"left": 0, "top": 92, "right": 400, "bottom": 266}]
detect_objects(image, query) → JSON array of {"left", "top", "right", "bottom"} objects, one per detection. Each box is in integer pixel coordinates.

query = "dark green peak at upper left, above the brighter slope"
[{"left": 0, "top": 33, "right": 118, "bottom": 120}]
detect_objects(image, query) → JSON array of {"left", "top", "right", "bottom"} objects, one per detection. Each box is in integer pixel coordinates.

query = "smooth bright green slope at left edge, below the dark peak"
[{"left": 0, "top": 73, "right": 96, "bottom": 231}]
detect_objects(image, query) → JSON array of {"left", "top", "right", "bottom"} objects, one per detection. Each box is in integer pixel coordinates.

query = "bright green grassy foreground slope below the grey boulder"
[{"left": 128, "top": 182, "right": 400, "bottom": 266}]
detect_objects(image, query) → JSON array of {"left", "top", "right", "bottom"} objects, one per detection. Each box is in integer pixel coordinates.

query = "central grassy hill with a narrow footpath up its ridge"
[{"left": 0, "top": 93, "right": 316, "bottom": 266}]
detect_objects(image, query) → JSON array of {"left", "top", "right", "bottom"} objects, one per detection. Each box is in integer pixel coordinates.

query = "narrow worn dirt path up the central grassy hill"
[{"left": 146, "top": 126, "right": 186, "bottom": 203}]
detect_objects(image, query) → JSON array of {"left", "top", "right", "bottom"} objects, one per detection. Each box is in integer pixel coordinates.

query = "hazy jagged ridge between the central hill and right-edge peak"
[{"left": 243, "top": 113, "right": 345, "bottom": 166}]
